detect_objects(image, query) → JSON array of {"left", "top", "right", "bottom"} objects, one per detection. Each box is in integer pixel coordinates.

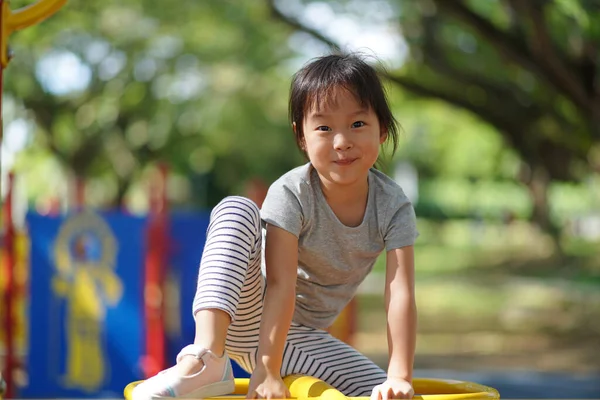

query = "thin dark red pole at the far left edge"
[{"left": 3, "top": 172, "right": 16, "bottom": 398}]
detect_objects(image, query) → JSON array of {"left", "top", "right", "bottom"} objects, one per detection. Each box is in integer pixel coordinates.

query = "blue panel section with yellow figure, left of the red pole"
[{"left": 23, "top": 213, "right": 145, "bottom": 398}]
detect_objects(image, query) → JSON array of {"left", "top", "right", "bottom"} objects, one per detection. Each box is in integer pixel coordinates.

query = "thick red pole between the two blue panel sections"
[{"left": 143, "top": 165, "right": 167, "bottom": 377}]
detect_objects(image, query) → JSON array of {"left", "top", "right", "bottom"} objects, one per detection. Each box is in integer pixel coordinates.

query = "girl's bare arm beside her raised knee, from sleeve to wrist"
[{"left": 257, "top": 225, "right": 298, "bottom": 378}]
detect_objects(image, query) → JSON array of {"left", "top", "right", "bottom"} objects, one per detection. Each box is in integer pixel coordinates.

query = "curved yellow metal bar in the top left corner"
[{"left": 0, "top": 0, "right": 67, "bottom": 68}]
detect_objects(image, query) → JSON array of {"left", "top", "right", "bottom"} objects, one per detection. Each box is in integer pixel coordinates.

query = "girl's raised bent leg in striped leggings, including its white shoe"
[{"left": 132, "top": 197, "right": 262, "bottom": 400}]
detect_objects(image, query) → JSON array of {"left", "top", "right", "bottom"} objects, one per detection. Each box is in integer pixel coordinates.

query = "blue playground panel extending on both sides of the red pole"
[{"left": 18, "top": 212, "right": 249, "bottom": 398}]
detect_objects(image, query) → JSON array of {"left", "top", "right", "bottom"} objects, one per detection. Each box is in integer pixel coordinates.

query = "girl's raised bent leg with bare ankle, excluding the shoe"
[{"left": 193, "top": 197, "right": 262, "bottom": 354}]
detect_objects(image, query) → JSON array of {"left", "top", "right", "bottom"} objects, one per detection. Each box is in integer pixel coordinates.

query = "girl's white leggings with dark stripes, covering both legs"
[{"left": 193, "top": 197, "right": 386, "bottom": 396}]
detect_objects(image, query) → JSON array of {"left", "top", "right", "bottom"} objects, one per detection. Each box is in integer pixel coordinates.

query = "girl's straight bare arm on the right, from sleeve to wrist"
[{"left": 385, "top": 246, "right": 417, "bottom": 385}]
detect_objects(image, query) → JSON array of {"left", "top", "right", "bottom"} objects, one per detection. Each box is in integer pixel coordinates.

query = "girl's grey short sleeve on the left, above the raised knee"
[{"left": 260, "top": 179, "right": 303, "bottom": 237}]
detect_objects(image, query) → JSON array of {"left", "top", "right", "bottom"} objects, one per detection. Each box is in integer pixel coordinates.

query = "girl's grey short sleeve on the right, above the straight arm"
[{"left": 384, "top": 201, "right": 419, "bottom": 251}]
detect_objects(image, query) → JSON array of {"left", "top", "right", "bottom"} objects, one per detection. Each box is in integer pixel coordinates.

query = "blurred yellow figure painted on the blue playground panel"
[{"left": 52, "top": 212, "right": 123, "bottom": 392}]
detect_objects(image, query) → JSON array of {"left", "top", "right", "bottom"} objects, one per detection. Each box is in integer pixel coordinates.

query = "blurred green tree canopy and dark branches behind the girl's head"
[{"left": 4, "top": 0, "right": 600, "bottom": 234}]
